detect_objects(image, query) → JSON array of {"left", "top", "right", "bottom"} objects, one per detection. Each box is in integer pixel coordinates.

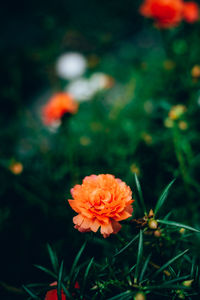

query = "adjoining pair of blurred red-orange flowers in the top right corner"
[{"left": 140, "top": 0, "right": 199, "bottom": 28}]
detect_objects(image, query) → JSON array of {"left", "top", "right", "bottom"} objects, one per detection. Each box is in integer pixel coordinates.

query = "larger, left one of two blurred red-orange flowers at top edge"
[{"left": 140, "top": 0, "right": 183, "bottom": 28}]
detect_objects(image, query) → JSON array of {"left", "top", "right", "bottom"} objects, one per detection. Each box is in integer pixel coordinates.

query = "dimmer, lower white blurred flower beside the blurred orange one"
[{"left": 66, "top": 78, "right": 95, "bottom": 102}]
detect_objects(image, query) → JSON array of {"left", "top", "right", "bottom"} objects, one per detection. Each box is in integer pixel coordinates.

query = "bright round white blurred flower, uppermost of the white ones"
[{"left": 56, "top": 52, "right": 87, "bottom": 79}]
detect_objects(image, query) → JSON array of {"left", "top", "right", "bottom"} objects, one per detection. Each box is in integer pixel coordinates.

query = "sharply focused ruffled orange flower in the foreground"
[{"left": 68, "top": 174, "right": 134, "bottom": 238}]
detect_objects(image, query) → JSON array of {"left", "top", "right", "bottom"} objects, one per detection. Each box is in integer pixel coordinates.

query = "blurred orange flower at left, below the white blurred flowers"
[{"left": 42, "top": 92, "right": 78, "bottom": 125}]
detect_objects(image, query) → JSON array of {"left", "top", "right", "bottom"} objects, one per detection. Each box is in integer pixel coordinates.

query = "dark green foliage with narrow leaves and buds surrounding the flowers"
[{"left": 0, "top": 0, "right": 200, "bottom": 300}]
